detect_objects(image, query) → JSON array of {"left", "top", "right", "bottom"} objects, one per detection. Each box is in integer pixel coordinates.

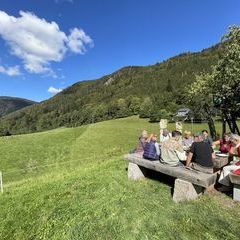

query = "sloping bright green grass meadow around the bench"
[{"left": 0, "top": 117, "right": 240, "bottom": 240}]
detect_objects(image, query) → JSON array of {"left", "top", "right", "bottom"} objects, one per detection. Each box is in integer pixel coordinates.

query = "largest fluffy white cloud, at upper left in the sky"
[{"left": 0, "top": 11, "right": 93, "bottom": 75}]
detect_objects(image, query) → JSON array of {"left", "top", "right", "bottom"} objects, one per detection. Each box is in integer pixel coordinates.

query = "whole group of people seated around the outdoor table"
[{"left": 135, "top": 129, "right": 240, "bottom": 192}]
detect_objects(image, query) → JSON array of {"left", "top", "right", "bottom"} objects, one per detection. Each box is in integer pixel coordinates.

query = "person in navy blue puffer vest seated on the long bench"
[{"left": 143, "top": 134, "right": 160, "bottom": 160}]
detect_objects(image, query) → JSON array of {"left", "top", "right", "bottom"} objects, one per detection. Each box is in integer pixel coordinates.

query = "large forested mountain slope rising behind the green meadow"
[{"left": 0, "top": 44, "right": 224, "bottom": 134}]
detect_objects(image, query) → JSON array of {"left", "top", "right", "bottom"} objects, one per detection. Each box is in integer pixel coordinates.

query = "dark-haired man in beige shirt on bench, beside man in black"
[{"left": 160, "top": 131, "right": 186, "bottom": 166}]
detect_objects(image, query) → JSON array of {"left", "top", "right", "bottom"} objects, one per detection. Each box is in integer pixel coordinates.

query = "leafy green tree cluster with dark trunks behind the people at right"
[{"left": 188, "top": 26, "right": 240, "bottom": 137}]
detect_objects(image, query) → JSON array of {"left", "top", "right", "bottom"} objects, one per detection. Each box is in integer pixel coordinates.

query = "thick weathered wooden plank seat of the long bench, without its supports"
[{"left": 124, "top": 154, "right": 217, "bottom": 188}]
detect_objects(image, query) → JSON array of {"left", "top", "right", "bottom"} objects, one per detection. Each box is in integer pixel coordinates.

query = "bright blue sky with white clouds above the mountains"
[{"left": 0, "top": 0, "right": 240, "bottom": 101}]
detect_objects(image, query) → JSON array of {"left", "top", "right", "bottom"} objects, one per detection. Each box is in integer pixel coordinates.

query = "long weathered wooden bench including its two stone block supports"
[{"left": 124, "top": 154, "right": 217, "bottom": 202}]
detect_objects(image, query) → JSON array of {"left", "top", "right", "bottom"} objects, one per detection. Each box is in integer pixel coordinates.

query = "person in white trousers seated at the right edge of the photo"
[{"left": 218, "top": 134, "right": 240, "bottom": 191}]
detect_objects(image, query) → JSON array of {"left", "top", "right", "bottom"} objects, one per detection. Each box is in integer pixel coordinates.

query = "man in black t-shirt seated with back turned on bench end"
[{"left": 186, "top": 133, "right": 215, "bottom": 173}]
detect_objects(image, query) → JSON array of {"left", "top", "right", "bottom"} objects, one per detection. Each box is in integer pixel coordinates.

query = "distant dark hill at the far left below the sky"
[{"left": 0, "top": 96, "right": 36, "bottom": 117}]
